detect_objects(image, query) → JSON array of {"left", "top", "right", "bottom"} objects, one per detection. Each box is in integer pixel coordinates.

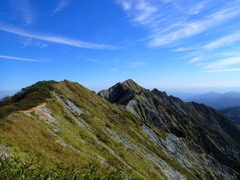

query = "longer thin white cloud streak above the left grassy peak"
[{"left": 0, "top": 25, "right": 117, "bottom": 49}]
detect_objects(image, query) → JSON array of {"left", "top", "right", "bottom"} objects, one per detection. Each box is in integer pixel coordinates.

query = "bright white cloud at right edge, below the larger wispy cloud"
[{"left": 182, "top": 32, "right": 240, "bottom": 69}]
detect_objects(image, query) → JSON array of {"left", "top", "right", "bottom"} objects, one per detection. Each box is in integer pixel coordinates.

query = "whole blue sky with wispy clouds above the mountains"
[{"left": 0, "top": 0, "right": 240, "bottom": 97}]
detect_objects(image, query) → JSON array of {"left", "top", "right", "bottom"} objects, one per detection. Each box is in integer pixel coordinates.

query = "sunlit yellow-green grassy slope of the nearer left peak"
[{"left": 0, "top": 81, "right": 199, "bottom": 179}]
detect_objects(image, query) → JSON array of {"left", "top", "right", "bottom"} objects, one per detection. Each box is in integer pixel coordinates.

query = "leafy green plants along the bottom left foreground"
[{"left": 0, "top": 156, "right": 127, "bottom": 180}]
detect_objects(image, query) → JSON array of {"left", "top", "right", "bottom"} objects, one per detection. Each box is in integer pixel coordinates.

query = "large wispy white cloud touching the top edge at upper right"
[{"left": 116, "top": 0, "right": 240, "bottom": 47}]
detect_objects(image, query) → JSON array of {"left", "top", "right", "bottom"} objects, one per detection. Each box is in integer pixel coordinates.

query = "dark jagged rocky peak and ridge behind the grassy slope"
[{"left": 99, "top": 80, "right": 240, "bottom": 176}]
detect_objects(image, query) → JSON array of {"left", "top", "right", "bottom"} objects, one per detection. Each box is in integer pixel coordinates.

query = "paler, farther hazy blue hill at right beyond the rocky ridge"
[{"left": 185, "top": 92, "right": 240, "bottom": 110}]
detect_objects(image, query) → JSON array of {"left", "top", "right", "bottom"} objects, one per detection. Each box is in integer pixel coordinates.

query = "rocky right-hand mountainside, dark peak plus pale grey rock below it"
[{"left": 99, "top": 80, "right": 240, "bottom": 179}]
